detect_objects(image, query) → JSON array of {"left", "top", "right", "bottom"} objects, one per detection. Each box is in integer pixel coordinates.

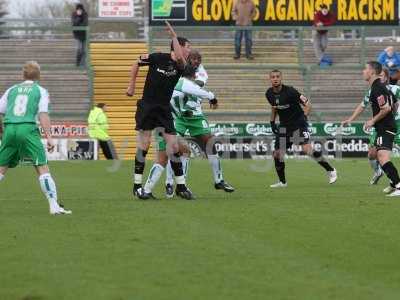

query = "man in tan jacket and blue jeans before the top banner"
[{"left": 232, "top": 0, "right": 256, "bottom": 59}]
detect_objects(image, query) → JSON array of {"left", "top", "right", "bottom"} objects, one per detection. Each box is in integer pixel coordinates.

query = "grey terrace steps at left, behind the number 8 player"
[{"left": 0, "top": 39, "right": 90, "bottom": 122}]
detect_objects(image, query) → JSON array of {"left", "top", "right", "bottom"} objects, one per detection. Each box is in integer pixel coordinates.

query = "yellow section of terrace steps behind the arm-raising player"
[{"left": 91, "top": 42, "right": 147, "bottom": 159}]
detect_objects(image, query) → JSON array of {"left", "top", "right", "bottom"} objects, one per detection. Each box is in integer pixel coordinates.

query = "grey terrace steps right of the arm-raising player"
[{"left": 154, "top": 40, "right": 399, "bottom": 122}]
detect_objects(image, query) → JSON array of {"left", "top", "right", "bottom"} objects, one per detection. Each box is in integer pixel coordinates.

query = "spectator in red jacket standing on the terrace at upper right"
[{"left": 313, "top": 4, "right": 336, "bottom": 63}]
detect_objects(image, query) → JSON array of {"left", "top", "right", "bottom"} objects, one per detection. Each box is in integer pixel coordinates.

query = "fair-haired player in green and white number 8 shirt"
[{"left": 0, "top": 61, "right": 71, "bottom": 215}]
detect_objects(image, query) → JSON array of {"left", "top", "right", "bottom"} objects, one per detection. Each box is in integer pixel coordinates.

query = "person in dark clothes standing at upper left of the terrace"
[{"left": 71, "top": 3, "right": 88, "bottom": 67}]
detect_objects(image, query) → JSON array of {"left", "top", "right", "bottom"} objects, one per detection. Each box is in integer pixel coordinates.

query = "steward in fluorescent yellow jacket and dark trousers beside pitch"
[{"left": 88, "top": 103, "right": 118, "bottom": 159}]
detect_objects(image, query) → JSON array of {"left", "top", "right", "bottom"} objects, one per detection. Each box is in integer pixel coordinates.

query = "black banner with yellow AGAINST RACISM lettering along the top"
[{"left": 149, "top": 0, "right": 399, "bottom": 26}]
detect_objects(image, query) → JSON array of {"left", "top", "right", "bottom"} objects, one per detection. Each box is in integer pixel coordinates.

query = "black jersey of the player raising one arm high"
[{"left": 139, "top": 53, "right": 182, "bottom": 107}]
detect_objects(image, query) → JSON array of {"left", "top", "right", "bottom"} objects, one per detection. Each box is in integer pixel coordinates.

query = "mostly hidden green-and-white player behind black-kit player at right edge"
[{"left": 342, "top": 69, "right": 400, "bottom": 186}]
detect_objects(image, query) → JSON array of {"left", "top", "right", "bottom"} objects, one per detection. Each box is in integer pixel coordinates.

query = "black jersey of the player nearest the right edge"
[{"left": 369, "top": 78, "right": 396, "bottom": 132}]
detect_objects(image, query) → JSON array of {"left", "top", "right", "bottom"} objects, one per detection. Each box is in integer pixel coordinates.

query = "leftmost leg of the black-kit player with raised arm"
[{"left": 133, "top": 130, "right": 151, "bottom": 196}]
